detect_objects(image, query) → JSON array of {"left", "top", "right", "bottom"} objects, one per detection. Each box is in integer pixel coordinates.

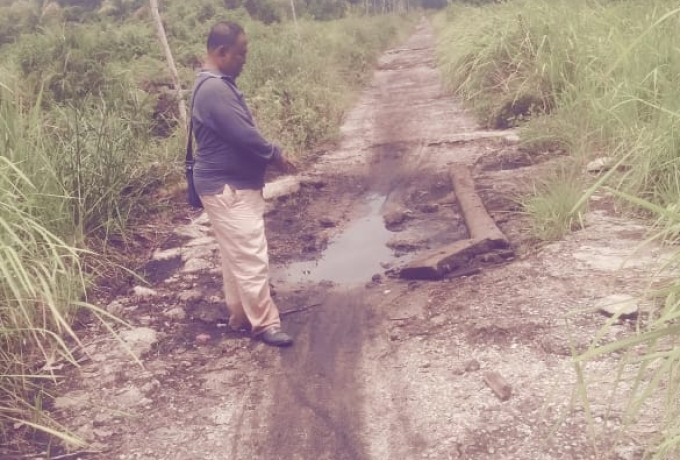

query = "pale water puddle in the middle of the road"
[{"left": 274, "top": 195, "right": 395, "bottom": 284}]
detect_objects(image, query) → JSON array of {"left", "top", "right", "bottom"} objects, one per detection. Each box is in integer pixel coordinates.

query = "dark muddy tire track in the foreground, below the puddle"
[{"left": 262, "top": 291, "right": 371, "bottom": 460}]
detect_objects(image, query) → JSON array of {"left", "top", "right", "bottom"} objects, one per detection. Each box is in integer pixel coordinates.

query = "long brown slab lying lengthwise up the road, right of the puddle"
[{"left": 449, "top": 164, "right": 510, "bottom": 249}]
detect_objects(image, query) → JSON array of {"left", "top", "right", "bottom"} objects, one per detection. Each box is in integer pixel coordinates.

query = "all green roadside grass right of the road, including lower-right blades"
[{"left": 436, "top": 0, "right": 680, "bottom": 459}]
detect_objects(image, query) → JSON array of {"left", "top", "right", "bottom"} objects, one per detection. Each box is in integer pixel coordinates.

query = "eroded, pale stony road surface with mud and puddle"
[{"left": 47, "top": 18, "right": 662, "bottom": 460}]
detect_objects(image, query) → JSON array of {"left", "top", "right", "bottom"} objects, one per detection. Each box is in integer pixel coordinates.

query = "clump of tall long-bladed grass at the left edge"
[{"left": 0, "top": 78, "right": 91, "bottom": 441}]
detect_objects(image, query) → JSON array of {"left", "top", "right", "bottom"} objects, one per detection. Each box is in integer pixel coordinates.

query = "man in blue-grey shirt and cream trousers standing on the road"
[{"left": 191, "top": 22, "right": 295, "bottom": 346}]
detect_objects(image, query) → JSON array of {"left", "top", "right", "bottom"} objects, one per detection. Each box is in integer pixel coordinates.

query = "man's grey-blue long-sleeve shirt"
[{"left": 191, "top": 70, "right": 281, "bottom": 195}]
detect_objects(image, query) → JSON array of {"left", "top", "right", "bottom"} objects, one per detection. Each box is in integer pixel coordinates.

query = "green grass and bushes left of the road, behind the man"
[{"left": 0, "top": 0, "right": 420, "bottom": 456}]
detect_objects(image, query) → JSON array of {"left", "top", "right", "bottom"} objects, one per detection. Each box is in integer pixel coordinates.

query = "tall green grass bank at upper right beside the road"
[{"left": 438, "top": 0, "right": 680, "bottom": 204}]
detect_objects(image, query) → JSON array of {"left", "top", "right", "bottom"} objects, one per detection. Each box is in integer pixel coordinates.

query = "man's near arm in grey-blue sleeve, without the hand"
[{"left": 196, "top": 78, "right": 281, "bottom": 162}]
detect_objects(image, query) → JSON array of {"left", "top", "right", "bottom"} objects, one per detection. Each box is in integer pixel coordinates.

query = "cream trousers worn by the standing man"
[{"left": 201, "top": 185, "right": 281, "bottom": 335}]
